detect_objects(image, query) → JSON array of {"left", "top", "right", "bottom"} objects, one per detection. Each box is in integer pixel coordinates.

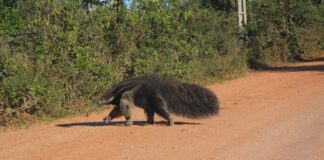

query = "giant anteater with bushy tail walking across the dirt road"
[{"left": 87, "top": 74, "right": 219, "bottom": 125}]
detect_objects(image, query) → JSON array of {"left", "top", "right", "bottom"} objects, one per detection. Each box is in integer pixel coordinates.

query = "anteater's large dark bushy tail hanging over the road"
[{"left": 159, "top": 79, "right": 219, "bottom": 118}]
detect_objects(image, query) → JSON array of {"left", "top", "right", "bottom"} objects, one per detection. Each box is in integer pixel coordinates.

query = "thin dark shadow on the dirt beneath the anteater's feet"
[{"left": 56, "top": 121, "right": 200, "bottom": 128}]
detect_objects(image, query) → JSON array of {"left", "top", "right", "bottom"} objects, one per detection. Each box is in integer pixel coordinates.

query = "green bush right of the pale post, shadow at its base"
[{"left": 245, "top": 0, "right": 324, "bottom": 68}]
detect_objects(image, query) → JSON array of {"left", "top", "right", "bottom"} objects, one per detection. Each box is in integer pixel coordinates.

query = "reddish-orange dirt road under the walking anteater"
[{"left": 0, "top": 58, "right": 324, "bottom": 160}]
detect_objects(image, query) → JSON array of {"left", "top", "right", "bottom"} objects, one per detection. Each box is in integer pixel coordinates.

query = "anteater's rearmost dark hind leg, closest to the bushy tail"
[{"left": 150, "top": 95, "right": 174, "bottom": 126}]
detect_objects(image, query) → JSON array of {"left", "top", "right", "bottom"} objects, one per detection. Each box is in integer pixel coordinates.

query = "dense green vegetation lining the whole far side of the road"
[{"left": 0, "top": 0, "right": 324, "bottom": 125}]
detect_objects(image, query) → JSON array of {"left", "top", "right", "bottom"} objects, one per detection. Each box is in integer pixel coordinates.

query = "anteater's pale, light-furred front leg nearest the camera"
[{"left": 119, "top": 90, "right": 135, "bottom": 126}]
